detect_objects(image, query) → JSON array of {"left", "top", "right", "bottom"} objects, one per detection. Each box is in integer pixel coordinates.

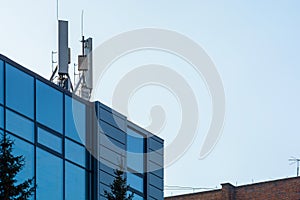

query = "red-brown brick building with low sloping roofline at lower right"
[{"left": 165, "top": 177, "right": 300, "bottom": 200}]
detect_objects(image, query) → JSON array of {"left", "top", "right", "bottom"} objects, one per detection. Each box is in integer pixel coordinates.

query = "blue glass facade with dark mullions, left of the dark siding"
[{"left": 0, "top": 57, "right": 91, "bottom": 200}]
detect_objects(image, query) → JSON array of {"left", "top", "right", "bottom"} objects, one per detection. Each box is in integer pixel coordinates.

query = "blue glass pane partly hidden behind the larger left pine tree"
[{"left": 8, "top": 134, "right": 34, "bottom": 188}]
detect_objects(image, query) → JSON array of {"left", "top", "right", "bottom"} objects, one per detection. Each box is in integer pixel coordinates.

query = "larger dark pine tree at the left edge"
[{"left": 0, "top": 134, "right": 36, "bottom": 200}]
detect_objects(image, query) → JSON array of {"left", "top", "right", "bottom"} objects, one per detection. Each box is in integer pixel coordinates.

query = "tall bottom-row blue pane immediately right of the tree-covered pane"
[{"left": 36, "top": 148, "right": 63, "bottom": 200}]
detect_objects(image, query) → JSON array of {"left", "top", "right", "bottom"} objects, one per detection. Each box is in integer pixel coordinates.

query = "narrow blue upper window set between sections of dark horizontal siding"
[{"left": 127, "top": 128, "right": 144, "bottom": 173}]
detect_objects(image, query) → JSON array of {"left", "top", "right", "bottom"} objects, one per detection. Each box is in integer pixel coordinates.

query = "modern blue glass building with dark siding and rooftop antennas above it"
[{"left": 0, "top": 55, "right": 163, "bottom": 200}]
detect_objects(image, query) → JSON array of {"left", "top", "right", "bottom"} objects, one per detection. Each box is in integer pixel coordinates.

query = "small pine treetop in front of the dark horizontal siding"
[{"left": 104, "top": 169, "right": 134, "bottom": 200}]
